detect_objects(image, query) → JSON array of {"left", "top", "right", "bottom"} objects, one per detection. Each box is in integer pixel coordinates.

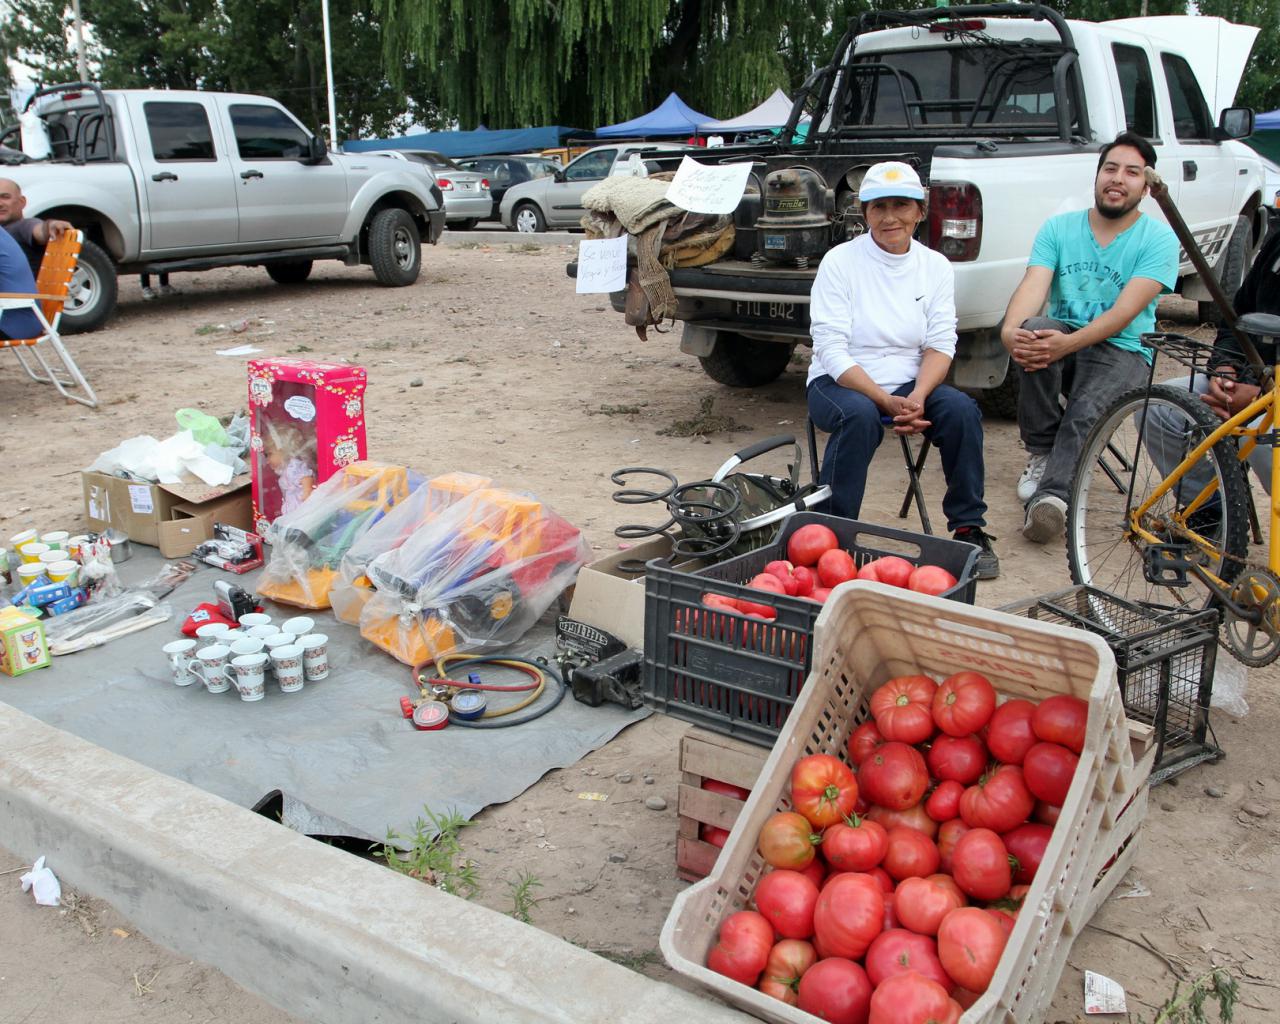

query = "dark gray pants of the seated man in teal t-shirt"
[{"left": 1015, "top": 316, "right": 1151, "bottom": 502}]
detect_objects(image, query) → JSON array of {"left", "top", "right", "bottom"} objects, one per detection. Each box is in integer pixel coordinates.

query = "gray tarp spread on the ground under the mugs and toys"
[{"left": 0, "top": 547, "right": 648, "bottom": 840}]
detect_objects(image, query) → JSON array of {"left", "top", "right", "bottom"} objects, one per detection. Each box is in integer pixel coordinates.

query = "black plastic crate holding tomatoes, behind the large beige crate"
[{"left": 644, "top": 512, "right": 978, "bottom": 746}]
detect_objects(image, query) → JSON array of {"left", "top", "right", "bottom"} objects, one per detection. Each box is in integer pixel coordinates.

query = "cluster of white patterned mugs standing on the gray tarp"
[{"left": 164, "top": 612, "right": 329, "bottom": 701}]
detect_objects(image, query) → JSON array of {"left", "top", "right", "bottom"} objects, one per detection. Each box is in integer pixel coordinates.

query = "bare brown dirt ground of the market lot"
[{"left": 0, "top": 243, "right": 1280, "bottom": 1024}]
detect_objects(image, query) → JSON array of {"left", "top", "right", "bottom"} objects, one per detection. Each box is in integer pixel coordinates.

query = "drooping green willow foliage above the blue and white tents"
[{"left": 376, "top": 0, "right": 868, "bottom": 128}]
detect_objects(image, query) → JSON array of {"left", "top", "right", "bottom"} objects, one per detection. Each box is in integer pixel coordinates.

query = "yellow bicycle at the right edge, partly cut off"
[{"left": 1066, "top": 314, "right": 1280, "bottom": 667}]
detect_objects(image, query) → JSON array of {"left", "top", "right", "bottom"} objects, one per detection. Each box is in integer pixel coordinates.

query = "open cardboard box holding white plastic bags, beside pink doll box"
[{"left": 81, "top": 472, "right": 250, "bottom": 558}]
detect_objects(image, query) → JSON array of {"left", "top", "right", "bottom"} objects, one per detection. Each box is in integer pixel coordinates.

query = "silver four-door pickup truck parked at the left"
[{"left": 0, "top": 83, "right": 444, "bottom": 330}]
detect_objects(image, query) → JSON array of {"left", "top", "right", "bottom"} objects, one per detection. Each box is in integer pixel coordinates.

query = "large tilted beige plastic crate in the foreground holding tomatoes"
[{"left": 660, "top": 581, "right": 1155, "bottom": 1024}]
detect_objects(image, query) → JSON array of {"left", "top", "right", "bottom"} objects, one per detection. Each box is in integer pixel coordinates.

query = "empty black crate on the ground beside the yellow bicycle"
[{"left": 1001, "top": 586, "right": 1222, "bottom": 785}]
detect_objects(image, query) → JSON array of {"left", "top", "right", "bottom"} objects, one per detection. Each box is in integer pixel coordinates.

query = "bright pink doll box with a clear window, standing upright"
[{"left": 248, "top": 358, "right": 367, "bottom": 532}]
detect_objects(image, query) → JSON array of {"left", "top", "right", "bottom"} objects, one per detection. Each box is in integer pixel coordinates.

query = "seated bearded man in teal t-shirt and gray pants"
[{"left": 1000, "top": 132, "right": 1179, "bottom": 544}]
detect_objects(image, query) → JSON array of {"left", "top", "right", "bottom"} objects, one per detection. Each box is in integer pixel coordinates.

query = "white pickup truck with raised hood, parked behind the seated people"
[{"left": 624, "top": 4, "right": 1266, "bottom": 413}]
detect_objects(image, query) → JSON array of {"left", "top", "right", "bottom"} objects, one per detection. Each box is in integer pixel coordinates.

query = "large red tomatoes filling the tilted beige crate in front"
[{"left": 707, "top": 672, "right": 1088, "bottom": 1024}]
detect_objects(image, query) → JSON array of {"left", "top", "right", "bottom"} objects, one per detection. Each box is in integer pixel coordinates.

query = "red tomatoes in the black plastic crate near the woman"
[{"left": 703, "top": 522, "right": 956, "bottom": 620}]
